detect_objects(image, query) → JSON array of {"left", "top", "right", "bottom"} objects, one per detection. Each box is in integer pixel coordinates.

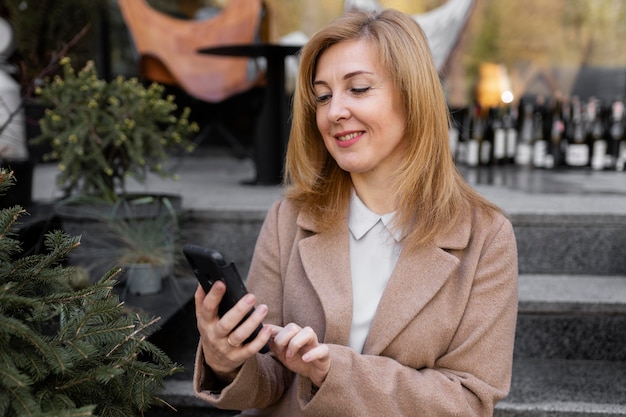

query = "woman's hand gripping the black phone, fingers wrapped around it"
[{"left": 194, "top": 281, "right": 272, "bottom": 382}]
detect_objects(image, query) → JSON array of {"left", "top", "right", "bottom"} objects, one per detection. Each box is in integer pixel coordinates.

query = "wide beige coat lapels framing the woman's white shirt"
[{"left": 297, "top": 203, "right": 470, "bottom": 354}]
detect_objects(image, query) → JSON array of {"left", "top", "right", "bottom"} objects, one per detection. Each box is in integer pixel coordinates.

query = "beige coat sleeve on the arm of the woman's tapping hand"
[{"left": 298, "top": 213, "right": 517, "bottom": 416}]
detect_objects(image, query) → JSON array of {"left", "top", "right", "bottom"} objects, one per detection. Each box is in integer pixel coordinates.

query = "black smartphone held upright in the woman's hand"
[{"left": 183, "top": 245, "right": 269, "bottom": 353}]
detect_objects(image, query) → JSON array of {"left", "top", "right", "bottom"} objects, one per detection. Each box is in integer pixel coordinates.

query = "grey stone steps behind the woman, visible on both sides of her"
[{"left": 147, "top": 167, "right": 626, "bottom": 417}]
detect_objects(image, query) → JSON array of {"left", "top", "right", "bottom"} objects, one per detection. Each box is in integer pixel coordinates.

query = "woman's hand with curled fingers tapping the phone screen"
[{"left": 268, "top": 323, "right": 330, "bottom": 387}]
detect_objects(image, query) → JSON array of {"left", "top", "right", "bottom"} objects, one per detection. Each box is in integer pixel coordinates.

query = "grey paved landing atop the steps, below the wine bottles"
[{"left": 33, "top": 147, "right": 626, "bottom": 215}]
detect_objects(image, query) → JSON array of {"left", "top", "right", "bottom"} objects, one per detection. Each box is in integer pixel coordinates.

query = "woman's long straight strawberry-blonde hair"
[{"left": 284, "top": 9, "right": 497, "bottom": 248}]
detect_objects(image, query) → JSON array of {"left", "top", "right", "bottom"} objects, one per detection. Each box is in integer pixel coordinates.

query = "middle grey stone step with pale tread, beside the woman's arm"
[{"left": 515, "top": 274, "right": 626, "bottom": 360}]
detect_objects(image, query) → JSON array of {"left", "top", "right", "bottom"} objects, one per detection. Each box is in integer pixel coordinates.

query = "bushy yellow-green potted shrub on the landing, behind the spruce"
[{"left": 34, "top": 58, "right": 198, "bottom": 276}]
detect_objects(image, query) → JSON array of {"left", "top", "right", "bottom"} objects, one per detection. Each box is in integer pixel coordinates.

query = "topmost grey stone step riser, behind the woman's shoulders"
[{"left": 182, "top": 208, "right": 626, "bottom": 276}]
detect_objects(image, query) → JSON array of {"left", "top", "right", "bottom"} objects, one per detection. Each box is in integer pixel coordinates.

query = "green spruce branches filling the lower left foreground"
[{"left": 0, "top": 168, "right": 182, "bottom": 417}]
